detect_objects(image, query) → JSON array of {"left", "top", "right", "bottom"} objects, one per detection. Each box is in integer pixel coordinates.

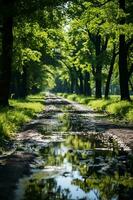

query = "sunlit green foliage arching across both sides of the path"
[{"left": 1, "top": 0, "right": 133, "bottom": 103}]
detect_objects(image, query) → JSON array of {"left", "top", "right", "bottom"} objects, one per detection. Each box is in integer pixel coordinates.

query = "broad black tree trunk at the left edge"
[{"left": 0, "top": 16, "right": 13, "bottom": 106}]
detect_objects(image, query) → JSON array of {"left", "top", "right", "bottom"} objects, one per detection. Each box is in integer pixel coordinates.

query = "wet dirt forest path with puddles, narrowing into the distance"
[{"left": 0, "top": 95, "right": 133, "bottom": 200}]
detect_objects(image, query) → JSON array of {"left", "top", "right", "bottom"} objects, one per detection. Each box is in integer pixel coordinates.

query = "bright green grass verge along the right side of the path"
[{"left": 59, "top": 93, "right": 133, "bottom": 123}]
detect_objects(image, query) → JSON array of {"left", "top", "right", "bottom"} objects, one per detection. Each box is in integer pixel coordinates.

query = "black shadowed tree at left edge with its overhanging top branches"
[{"left": 0, "top": 0, "right": 74, "bottom": 106}]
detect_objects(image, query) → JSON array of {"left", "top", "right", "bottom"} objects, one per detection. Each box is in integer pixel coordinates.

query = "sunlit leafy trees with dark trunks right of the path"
[{"left": 54, "top": 0, "right": 133, "bottom": 100}]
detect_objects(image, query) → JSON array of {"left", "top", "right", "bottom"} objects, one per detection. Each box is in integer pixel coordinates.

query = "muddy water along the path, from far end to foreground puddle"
[{"left": 15, "top": 96, "right": 133, "bottom": 200}]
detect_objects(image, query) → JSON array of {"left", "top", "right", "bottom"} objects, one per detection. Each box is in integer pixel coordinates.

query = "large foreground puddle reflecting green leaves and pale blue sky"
[{"left": 16, "top": 134, "right": 133, "bottom": 200}]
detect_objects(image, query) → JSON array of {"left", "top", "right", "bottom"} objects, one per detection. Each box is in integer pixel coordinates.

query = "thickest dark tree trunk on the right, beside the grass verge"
[{"left": 119, "top": 0, "right": 130, "bottom": 100}]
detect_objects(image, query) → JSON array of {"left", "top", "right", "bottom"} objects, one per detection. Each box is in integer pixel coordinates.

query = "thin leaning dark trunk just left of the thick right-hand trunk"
[{"left": 105, "top": 45, "right": 116, "bottom": 99}]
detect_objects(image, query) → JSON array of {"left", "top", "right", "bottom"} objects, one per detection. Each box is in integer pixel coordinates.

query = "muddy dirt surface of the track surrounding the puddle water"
[{"left": 0, "top": 96, "right": 133, "bottom": 200}]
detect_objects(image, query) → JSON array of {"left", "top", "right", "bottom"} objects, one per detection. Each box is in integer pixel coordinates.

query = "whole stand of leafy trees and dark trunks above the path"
[{"left": 0, "top": 0, "right": 133, "bottom": 106}]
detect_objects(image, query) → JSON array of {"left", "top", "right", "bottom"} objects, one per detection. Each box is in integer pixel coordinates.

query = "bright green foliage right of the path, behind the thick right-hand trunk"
[{"left": 53, "top": 0, "right": 133, "bottom": 99}]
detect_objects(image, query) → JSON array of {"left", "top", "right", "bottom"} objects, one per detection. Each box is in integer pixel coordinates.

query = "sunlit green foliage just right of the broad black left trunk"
[{"left": 12, "top": 14, "right": 64, "bottom": 97}]
